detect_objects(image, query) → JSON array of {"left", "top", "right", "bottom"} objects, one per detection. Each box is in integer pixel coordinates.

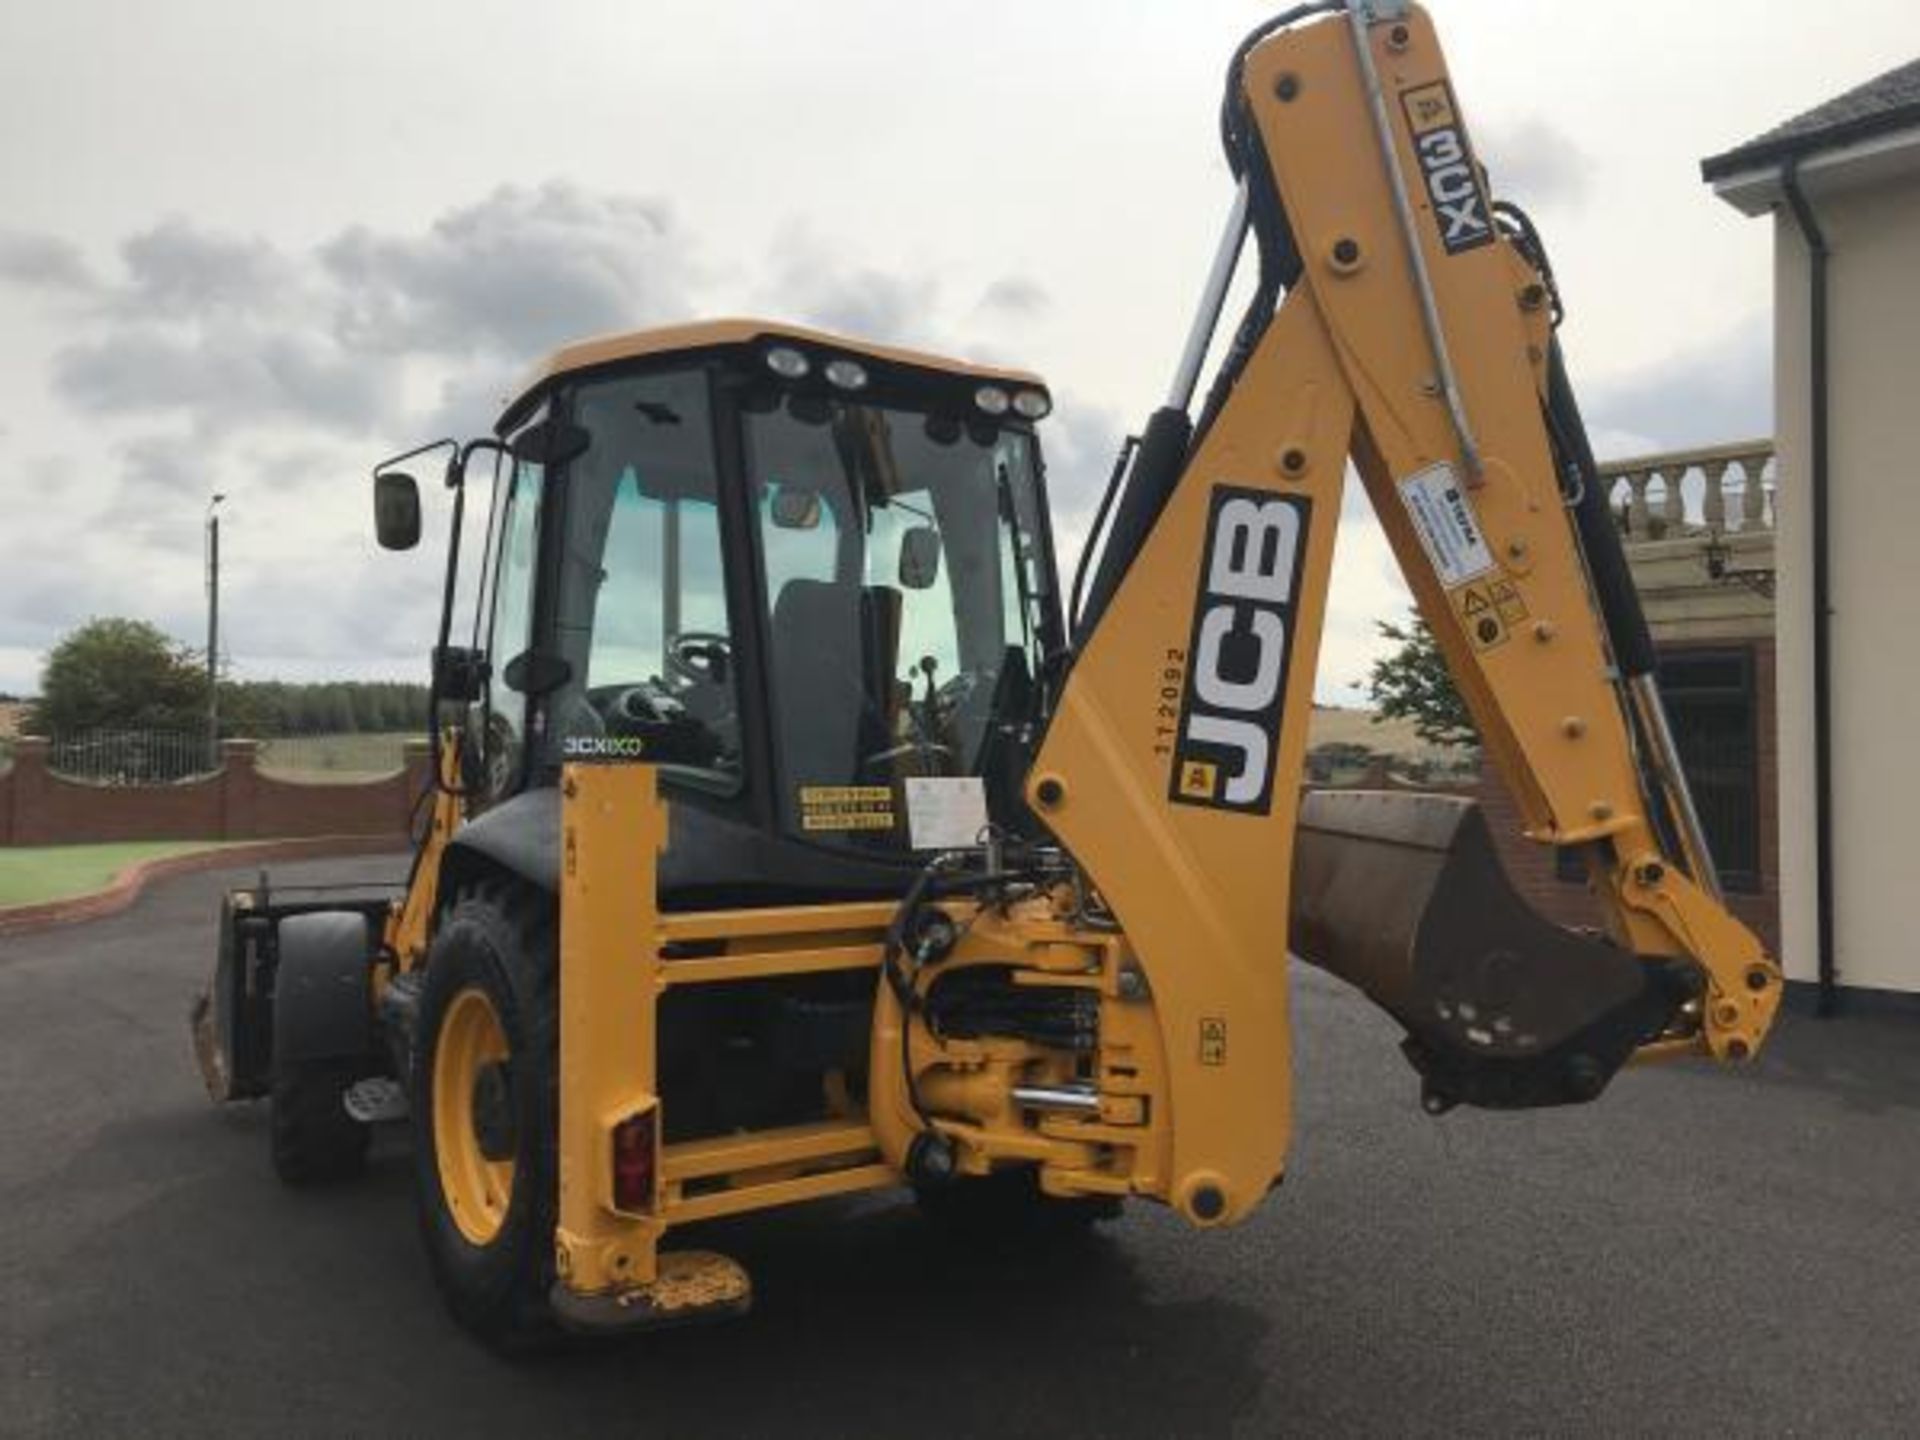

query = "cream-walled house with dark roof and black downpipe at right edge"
[{"left": 1701, "top": 60, "right": 1920, "bottom": 1006}]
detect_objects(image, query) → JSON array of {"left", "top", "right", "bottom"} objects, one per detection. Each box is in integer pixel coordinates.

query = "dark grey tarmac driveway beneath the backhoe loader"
[{"left": 0, "top": 860, "right": 1920, "bottom": 1440}]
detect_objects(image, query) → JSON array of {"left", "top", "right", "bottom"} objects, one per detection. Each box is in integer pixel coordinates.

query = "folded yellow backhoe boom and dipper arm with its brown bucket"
[{"left": 1027, "top": 0, "right": 1780, "bottom": 1204}]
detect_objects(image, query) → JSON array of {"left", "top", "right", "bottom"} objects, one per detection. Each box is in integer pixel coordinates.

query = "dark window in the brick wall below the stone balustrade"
[{"left": 1557, "top": 649, "right": 1761, "bottom": 893}]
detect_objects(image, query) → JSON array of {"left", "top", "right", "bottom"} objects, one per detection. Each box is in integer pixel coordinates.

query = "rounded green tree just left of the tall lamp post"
[{"left": 31, "top": 618, "right": 207, "bottom": 735}]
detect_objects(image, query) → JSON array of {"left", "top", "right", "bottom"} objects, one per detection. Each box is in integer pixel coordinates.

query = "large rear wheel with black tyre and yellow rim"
[{"left": 411, "top": 885, "right": 559, "bottom": 1352}]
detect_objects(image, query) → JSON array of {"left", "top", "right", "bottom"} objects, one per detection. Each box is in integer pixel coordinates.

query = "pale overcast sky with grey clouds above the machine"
[{"left": 0, "top": 0, "right": 1920, "bottom": 699}]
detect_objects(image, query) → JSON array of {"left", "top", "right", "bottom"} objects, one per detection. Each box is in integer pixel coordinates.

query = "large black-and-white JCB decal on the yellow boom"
[{"left": 1167, "top": 486, "right": 1313, "bottom": 814}]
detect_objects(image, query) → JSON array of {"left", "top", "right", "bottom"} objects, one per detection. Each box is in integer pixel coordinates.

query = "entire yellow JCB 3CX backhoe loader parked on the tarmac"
[{"left": 187, "top": 0, "right": 1782, "bottom": 1346}]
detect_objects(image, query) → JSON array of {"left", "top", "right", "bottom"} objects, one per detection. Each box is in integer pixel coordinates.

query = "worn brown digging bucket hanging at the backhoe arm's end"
[{"left": 1288, "top": 791, "right": 1697, "bottom": 1114}]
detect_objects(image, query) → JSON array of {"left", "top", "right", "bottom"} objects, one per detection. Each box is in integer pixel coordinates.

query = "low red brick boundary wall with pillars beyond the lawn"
[{"left": 0, "top": 737, "right": 432, "bottom": 845}]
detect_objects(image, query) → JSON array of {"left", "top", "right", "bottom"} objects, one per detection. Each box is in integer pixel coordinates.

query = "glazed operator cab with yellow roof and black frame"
[{"left": 382, "top": 321, "right": 1064, "bottom": 904}]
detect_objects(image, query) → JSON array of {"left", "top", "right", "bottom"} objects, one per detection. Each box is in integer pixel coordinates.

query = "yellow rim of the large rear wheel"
[{"left": 434, "top": 989, "right": 513, "bottom": 1244}]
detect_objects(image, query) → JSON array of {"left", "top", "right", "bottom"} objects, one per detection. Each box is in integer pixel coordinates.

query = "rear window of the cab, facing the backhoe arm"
[{"left": 745, "top": 397, "right": 1046, "bottom": 841}]
